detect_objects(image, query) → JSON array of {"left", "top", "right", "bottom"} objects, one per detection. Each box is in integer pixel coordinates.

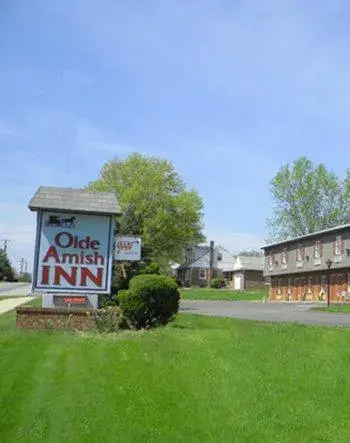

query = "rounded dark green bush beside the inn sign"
[{"left": 118, "top": 275, "right": 180, "bottom": 329}]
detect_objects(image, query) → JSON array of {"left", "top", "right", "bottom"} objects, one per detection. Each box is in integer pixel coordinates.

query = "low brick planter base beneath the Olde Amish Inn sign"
[{"left": 16, "top": 307, "right": 96, "bottom": 331}]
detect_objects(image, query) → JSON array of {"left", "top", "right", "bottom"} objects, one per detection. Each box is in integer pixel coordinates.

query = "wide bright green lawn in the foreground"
[{"left": 0, "top": 306, "right": 350, "bottom": 443}]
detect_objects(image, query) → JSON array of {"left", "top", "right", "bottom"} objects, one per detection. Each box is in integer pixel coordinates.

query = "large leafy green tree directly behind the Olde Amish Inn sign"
[{"left": 88, "top": 154, "right": 204, "bottom": 266}]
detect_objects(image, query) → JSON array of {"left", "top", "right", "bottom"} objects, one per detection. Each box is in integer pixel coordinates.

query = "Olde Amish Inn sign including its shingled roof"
[{"left": 29, "top": 187, "right": 120, "bottom": 295}]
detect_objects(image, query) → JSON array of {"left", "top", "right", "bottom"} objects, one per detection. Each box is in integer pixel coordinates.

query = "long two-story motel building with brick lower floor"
[{"left": 263, "top": 224, "right": 350, "bottom": 303}]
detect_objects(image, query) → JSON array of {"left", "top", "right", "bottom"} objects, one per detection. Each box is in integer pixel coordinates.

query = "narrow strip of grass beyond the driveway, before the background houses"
[{"left": 180, "top": 288, "right": 267, "bottom": 300}]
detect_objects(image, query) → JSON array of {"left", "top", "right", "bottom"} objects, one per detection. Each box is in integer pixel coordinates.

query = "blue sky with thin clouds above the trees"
[{"left": 0, "top": 0, "right": 350, "bottom": 272}]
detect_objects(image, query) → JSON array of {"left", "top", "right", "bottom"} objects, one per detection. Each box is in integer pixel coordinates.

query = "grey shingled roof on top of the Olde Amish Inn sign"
[{"left": 29, "top": 186, "right": 121, "bottom": 215}]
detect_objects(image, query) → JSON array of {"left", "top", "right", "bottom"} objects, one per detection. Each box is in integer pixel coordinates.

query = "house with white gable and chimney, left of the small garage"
[{"left": 176, "top": 246, "right": 235, "bottom": 286}]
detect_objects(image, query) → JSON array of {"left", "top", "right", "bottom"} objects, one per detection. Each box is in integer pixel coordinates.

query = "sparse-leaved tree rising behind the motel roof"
[{"left": 268, "top": 157, "right": 350, "bottom": 240}]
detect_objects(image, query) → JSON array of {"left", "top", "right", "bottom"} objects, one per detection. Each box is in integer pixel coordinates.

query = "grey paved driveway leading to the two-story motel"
[{"left": 180, "top": 300, "right": 350, "bottom": 327}]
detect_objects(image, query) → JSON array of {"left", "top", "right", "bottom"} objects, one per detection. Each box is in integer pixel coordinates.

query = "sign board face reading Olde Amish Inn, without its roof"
[{"left": 33, "top": 211, "right": 114, "bottom": 294}]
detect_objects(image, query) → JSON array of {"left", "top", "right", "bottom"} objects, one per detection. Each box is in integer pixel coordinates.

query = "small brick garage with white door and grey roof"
[{"left": 224, "top": 255, "right": 265, "bottom": 290}]
